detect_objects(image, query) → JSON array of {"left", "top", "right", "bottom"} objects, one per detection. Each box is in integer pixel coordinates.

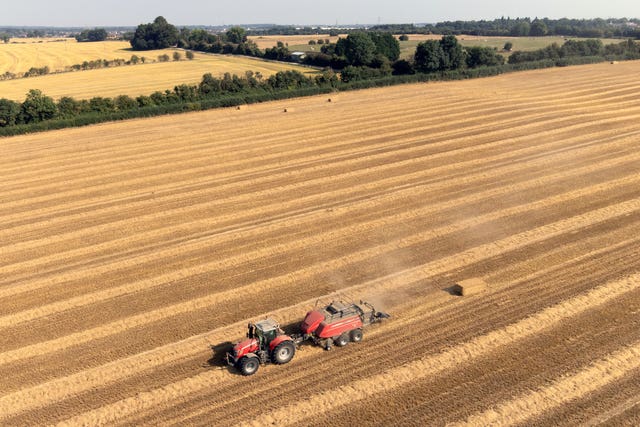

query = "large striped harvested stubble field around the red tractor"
[{"left": 0, "top": 62, "right": 640, "bottom": 426}]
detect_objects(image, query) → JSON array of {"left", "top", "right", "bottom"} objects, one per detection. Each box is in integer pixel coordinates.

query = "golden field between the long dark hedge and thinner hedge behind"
[{"left": 0, "top": 49, "right": 317, "bottom": 101}]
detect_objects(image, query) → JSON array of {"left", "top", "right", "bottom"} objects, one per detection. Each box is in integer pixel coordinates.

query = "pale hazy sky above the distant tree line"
[{"left": 0, "top": 0, "right": 640, "bottom": 27}]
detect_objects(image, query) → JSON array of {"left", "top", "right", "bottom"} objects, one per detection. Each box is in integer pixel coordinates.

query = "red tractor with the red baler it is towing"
[{"left": 226, "top": 301, "right": 389, "bottom": 375}]
